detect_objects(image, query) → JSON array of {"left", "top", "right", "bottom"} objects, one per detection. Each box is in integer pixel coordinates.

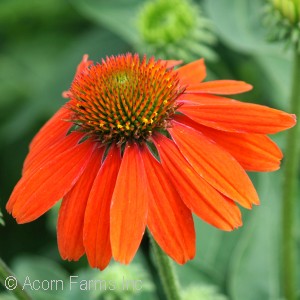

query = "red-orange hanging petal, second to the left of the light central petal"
[{"left": 57, "top": 148, "right": 104, "bottom": 260}]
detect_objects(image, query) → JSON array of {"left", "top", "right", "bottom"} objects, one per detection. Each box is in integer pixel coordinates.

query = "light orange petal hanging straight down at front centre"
[{"left": 110, "top": 144, "right": 150, "bottom": 263}]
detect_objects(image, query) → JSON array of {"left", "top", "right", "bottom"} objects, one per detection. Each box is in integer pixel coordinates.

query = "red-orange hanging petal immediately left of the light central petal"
[{"left": 83, "top": 146, "right": 121, "bottom": 270}]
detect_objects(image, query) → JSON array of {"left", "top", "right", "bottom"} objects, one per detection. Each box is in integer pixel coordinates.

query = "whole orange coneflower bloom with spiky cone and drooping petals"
[{"left": 7, "top": 54, "right": 296, "bottom": 269}]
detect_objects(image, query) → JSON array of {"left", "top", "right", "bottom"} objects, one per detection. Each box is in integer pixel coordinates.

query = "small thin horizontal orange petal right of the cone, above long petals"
[{"left": 185, "top": 80, "right": 253, "bottom": 95}]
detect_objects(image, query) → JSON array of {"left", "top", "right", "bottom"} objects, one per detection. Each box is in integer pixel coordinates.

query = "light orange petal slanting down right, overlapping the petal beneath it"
[{"left": 169, "top": 122, "right": 259, "bottom": 208}]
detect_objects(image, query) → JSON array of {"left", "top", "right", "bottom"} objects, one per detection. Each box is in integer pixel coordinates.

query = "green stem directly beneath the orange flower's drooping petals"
[{"left": 148, "top": 232, "right": 181, "bottom": 300}]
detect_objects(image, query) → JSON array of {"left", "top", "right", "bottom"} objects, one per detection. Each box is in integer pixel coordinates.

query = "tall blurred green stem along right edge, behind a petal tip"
[{"left": 282, "top": 50, "right": 300, "bottom": 300}]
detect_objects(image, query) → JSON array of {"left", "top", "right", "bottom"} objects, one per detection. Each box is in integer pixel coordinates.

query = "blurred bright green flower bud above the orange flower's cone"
[{"left": 137, "top": 0, "right": 216, "bottom": 61}]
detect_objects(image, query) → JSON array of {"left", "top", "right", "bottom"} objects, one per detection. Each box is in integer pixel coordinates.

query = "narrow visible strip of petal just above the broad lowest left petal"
[{"left": 22, "top": 132, "right": 84, "bottom": 175}]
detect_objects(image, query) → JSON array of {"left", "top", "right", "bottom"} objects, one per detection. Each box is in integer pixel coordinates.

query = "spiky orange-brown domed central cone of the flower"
[{"left": 68, "top": 54, "right": 184, "bottom": 143}]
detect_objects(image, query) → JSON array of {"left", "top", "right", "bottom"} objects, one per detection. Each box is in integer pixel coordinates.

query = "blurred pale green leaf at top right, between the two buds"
[{"left": 205, "top": 0, "right": 291, "bottom": 109}]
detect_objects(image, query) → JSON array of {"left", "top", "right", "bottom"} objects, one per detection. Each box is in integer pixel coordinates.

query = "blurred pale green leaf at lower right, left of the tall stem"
[{"left": 228, "top": 172, "right": 281, "bottom": 300}]
